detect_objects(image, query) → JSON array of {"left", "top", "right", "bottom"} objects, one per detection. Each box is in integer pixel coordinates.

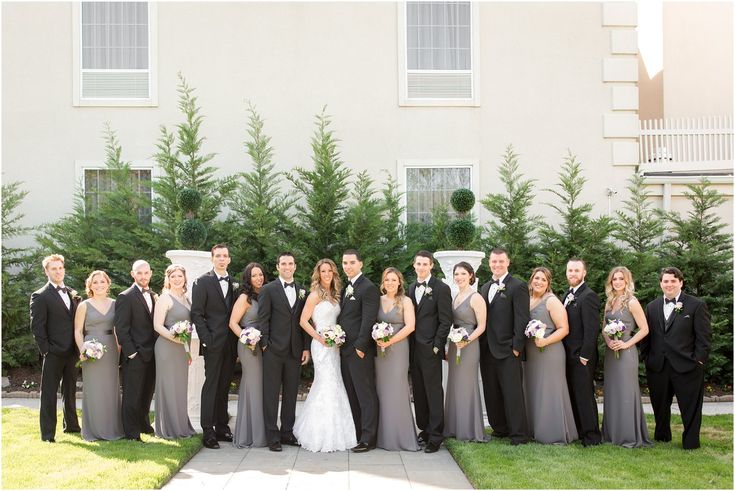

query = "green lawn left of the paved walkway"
[{"left": 2, "top": 408, "right": 202, "bottom": 489}]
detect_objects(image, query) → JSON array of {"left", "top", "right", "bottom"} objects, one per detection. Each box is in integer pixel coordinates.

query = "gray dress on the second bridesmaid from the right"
[{"left": 523, "top": 293, "right": 579, "bottom": 444}]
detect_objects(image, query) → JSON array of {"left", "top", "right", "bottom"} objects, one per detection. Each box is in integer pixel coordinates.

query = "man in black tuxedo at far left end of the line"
[{"left": 31, "top": 254, "right": 81, "bottom": 443}]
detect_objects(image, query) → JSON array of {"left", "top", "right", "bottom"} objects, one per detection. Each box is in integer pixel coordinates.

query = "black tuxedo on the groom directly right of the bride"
[{"left": 337, "top": 274, "right": 380, "bottom": 446}]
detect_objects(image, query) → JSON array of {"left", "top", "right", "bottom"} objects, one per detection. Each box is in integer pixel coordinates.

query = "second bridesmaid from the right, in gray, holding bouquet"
[{"left": 524, "top": 267, "right": 579, "bottom": 444}]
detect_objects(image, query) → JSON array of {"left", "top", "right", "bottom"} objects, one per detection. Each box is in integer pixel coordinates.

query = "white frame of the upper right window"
[{"left": 396, "top": 1, "right": 480, "bottom": 107}]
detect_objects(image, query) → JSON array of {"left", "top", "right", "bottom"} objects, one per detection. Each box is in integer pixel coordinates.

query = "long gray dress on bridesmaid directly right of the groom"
[{"left": 375, "top": 306, "right": 420, "bottom": 451}]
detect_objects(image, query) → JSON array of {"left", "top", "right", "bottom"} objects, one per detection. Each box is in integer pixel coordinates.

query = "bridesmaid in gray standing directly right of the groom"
[{"left": 375, "top": 267, "right": 420, "bottom": 451}]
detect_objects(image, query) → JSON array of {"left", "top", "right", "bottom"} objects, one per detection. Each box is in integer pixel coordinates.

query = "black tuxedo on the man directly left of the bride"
[{"left": 258, "top": 278, "right": 311, "bottom": 444}]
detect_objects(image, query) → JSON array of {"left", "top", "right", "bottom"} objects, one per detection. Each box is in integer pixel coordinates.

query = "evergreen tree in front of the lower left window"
[{"left": 37, "top": 124, "right": 167, "bottom": 294}]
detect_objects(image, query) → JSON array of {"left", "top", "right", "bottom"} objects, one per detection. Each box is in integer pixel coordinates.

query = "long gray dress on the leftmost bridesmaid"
[{"left": 82, "top": 300, "right": 124, "bottom": 442}]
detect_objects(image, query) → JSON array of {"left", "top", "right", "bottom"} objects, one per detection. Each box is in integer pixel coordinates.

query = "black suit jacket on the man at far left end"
[{"left": 31, "top": 282, "right": 81, "bottom": 356}]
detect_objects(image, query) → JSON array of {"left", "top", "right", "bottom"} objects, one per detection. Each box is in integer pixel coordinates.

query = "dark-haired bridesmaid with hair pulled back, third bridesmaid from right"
[{"left": 444, "top": 261, "right": 487, "bottom": 442}]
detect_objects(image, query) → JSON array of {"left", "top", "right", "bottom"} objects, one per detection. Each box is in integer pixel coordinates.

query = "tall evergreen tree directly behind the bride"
[{"left": 286, "top": 106, "right": 351, "bottom": 279}]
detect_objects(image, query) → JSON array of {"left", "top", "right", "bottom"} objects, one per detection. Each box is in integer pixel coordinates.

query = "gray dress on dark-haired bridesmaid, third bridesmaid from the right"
[{"left": 444, "top": 293, "right": 486, "bottom": 442}]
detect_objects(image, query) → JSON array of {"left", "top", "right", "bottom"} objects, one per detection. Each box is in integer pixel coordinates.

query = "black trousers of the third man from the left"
[{"left": 200, "top": 343, "right": 235, "bottom": 439}]
